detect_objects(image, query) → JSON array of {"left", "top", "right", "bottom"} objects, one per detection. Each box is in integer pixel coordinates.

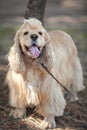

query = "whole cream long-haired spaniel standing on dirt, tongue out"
[{"left": 7, "top": 18, "right": 84, "bottom": 129}]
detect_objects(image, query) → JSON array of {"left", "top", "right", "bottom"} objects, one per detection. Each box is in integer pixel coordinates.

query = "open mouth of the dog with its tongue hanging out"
[{"left": 25, "top": 44, "right": 41, "bottom": 58}]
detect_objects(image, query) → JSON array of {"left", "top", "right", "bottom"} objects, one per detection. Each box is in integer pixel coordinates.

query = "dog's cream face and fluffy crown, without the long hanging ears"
[{"left": 15, "top": 18, "right": 49, "bottom": 58}]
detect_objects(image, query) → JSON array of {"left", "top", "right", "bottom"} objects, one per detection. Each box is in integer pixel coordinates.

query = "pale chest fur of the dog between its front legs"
[{"left": 25, "top": 64, "right": 44, "bottom": 107}]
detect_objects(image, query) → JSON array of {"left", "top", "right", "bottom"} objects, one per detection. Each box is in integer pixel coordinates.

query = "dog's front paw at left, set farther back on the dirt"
[{"left": 10, "top": 109, "right": 25, "bottom": 119}]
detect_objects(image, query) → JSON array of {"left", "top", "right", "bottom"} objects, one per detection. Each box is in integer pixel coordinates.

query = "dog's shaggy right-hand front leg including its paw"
[{"left": 38, "top": 82, "right": 66, "bottom": 129}]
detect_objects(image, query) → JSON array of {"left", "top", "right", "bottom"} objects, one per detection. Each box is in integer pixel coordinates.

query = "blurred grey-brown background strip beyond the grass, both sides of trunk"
[{"left": 0, "top": 0, "right": 87, "bottom": 29}]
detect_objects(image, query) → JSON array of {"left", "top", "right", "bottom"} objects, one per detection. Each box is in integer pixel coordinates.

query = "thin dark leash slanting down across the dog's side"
[{"left": 40, "top": 62, "right": 73, "bottom": 96}]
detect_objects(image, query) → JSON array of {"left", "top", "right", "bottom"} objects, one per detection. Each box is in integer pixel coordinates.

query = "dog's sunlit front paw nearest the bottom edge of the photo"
[{"left": 40, "top": 118, "right": 56, "bottom": 129}]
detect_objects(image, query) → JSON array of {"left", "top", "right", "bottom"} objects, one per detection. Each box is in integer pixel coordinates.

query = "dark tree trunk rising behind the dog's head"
[{"left": 25, "top": 0, "right": 47, "bottom": 23}]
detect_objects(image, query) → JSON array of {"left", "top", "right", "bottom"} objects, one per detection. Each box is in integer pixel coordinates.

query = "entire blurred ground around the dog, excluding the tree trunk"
[{"left": 0, "top": 0, "right": 87, "bottom": 130}]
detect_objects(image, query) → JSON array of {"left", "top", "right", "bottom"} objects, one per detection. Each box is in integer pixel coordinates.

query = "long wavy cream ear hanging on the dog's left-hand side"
[{"left": 7, "top": 31, "right": 25, "bottom": 73}]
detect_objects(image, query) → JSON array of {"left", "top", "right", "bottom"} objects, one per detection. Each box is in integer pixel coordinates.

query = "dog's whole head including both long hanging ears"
[{"left": 7, "top": 18, "right": 51, "bottom": 73}]
